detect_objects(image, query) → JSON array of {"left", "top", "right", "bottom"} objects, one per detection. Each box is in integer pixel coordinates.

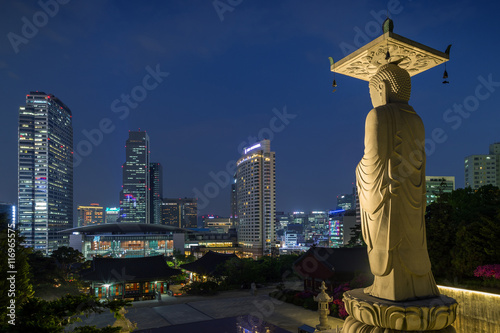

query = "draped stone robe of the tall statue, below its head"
[{"left": 356, "top": 103, "right": 439, "bottom": 301}]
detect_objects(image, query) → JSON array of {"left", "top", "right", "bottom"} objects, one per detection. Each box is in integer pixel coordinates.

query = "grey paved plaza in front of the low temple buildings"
[{"left": 68, "top": 287, "right": 343, "bottom": 333}]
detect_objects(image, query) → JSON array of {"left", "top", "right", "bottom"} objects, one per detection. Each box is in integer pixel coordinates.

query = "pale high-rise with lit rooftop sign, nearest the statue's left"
[{"left": 236, "top": 140, "right": 276, "bottom": 258}]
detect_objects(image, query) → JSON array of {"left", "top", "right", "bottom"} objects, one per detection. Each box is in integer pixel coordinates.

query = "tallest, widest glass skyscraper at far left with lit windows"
[{"left": 18, "top": 91, "right": 73, "bottom": 255}]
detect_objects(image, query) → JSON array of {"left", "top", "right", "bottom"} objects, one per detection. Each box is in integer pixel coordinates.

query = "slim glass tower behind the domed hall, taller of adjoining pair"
[{"left": 120, "top": 131, "right": 150, "bottom": 223}]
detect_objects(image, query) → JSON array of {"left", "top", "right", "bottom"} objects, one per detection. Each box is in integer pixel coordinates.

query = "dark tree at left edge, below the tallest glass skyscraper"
[{"left": 0, "top": 214, "right": 33, "bottom": 324}]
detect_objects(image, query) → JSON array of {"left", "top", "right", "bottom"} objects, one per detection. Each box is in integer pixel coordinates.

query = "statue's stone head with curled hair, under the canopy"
[{"left": 369, "top": 63, "right": 411, "bottom": 108}]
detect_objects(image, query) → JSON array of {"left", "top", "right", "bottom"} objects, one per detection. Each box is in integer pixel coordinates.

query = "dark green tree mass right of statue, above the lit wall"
[{"left": 426, "top": 185, "right": 500, "bottom": 280}]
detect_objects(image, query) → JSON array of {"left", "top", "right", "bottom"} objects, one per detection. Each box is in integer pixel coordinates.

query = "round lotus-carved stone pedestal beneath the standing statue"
[{"left": 342, "top": 289, "right": 458, "bottom": 333}]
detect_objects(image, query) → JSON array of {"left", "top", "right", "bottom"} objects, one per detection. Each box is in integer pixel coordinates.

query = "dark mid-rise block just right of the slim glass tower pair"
[{"left": 161, "top": 198, "right": 198, "bottom": 228}]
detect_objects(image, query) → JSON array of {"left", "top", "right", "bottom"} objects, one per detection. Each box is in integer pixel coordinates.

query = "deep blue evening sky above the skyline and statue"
[{"left": 0, "top": 0, "right": 500, "bottom": 215}]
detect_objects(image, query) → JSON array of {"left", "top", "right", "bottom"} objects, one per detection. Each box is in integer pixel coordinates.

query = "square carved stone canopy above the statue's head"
[{"left": 330, "top": 31, "right": 449, "bottom": 81}]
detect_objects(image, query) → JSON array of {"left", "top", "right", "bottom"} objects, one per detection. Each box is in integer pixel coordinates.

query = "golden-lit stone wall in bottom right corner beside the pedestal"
[{"left": 438, "top": 286, "right": 500, "bottom": 333}]
